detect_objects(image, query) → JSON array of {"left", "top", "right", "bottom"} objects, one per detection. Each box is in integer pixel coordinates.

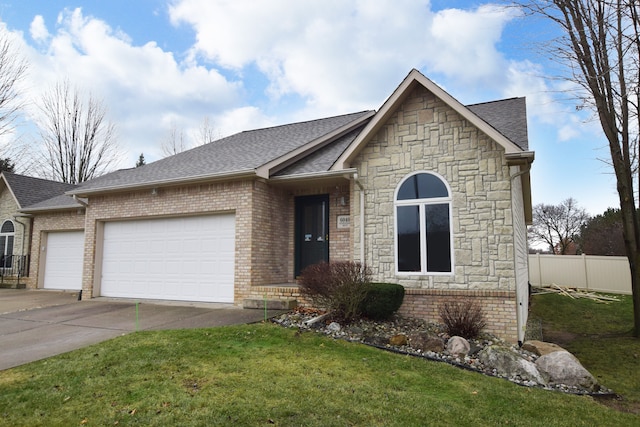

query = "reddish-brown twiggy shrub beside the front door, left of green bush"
[{"left": 299, "top": 261, "right": 371, "bottom": 322}]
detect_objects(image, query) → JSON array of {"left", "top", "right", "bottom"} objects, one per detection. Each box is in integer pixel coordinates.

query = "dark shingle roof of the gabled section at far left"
[{"left": 2, "top": 172, "right": 76, "bottom": 208}]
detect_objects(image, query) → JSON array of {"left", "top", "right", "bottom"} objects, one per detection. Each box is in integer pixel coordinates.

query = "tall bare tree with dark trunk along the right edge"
[{"left": 516, "top": 0, "right": 640, "bottom": 337}]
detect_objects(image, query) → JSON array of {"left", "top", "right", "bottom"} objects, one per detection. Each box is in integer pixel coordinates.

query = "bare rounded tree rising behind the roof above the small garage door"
[{"left": 38, "top": 80, "right": 119, "bottom": 184}]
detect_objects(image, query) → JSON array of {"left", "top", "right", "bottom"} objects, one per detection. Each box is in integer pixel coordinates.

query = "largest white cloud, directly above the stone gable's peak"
[{"left": 169, "top": 0, "right": 536, "bottom": 119}]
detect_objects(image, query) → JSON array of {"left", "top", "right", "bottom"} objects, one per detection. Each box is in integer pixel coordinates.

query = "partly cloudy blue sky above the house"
[{"left": 0, "top": 0, "right": 618, "bottom": 215}]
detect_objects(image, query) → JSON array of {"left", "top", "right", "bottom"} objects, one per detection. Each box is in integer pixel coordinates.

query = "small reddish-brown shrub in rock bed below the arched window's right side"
[{"left": 440, "top": 300, "right": 487, "bottom": 338}]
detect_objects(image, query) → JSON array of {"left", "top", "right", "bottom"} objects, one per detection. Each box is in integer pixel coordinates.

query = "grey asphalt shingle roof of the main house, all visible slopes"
[{"left": 66, "top": 93, "right": 528, "bottom": 197}]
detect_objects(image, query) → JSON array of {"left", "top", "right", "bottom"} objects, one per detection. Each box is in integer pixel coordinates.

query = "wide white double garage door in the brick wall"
[{"left": 100, "top": 214, "right": 235, "bottom": 302}]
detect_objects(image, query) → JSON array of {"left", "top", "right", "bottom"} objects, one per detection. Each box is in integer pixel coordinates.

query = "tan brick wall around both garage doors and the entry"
[{"left": 28, "top": 180, "right": 351, "bottom": 304}]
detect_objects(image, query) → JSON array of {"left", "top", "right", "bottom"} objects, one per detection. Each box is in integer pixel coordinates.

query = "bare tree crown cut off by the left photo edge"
[{"left": 0, "top": 30, "right": 28, "bottom": 135}]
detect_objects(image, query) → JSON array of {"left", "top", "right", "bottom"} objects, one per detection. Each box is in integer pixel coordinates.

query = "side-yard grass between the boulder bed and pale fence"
[{"left": 529, "top": 294, "right": 640, "bottom": 414}]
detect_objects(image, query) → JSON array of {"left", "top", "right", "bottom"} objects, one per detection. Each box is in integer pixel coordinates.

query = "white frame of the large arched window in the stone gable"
[{"left": 393, "top": 170, "right": 455, "bottom": 276}]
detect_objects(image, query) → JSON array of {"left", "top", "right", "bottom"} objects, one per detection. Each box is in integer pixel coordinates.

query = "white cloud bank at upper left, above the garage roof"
[{"left": 20, "top": 8, "right": 242, "bottom": 163}]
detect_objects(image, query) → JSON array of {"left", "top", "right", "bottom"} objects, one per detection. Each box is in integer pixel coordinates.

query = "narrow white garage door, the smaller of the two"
[{"left": 44, "top": 231, "right": 84, "bottom": 290}]
